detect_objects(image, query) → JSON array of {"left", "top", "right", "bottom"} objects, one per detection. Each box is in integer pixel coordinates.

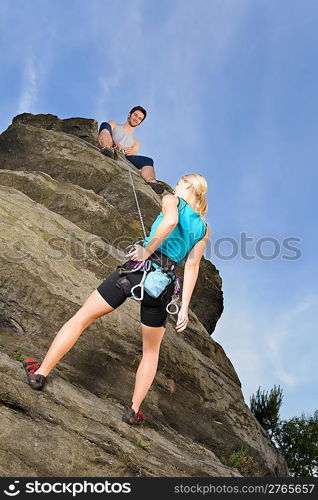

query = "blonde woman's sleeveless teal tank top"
[{"left": 144, "top": 197, "right": 207, "bottom": 264}]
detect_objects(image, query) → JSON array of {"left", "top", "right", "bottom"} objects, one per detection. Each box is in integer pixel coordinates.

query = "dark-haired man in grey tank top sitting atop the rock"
[{"left": 98, "top": 106, "right": 164, "bottom": 194}]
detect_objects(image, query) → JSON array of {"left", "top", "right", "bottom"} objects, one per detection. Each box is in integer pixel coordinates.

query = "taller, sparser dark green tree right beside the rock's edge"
[{"left": 250, "top": 385, "right": 283, "bottom": 438}]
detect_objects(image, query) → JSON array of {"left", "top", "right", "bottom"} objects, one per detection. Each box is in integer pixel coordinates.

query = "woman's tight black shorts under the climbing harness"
[{"left": 97, "top": 260, "right": 174, "bottom": 327}]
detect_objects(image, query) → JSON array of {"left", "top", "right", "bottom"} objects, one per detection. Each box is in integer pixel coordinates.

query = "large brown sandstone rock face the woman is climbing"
[{"left": 0, "top": 114, "right": 288, "bottom": 476}]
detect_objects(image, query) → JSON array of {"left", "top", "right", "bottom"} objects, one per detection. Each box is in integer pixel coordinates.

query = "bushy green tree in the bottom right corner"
[{"left": 275, "top": 410, "right": 318, "bottom": 477}]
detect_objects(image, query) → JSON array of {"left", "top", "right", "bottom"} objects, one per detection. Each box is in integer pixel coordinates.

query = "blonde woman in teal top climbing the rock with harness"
[{"left": 23, "top": 174, "right": 210, "bottom": 425}]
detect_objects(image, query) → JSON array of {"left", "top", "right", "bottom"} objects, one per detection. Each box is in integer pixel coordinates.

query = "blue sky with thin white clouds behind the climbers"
[{"left": 0, "top": 0, "right": 318, "bottom": 418}]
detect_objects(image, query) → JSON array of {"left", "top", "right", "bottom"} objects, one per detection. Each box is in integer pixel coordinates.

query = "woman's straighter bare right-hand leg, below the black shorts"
[{"left": 132, "top": 324, "right": 165, "bottom": 412}]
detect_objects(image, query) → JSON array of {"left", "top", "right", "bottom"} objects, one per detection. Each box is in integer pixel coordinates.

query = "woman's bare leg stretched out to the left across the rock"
[{"left": 34, "top": 290, "right": 114, "bottom": 376}]
